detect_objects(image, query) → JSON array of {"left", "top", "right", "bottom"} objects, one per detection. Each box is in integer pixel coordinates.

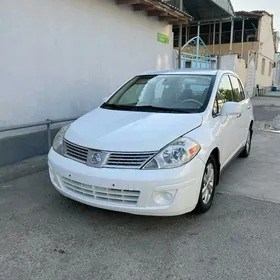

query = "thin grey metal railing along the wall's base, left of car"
[{"left": 0, "top": 118, "right": 77, "bottom": 149}]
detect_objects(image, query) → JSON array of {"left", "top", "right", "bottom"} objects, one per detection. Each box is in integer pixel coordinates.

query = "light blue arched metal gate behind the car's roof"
[{"left": 181, "top": 36, "right": 212, "bottom": 69}]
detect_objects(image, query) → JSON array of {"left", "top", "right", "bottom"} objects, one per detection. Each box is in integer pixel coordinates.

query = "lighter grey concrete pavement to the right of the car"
[{"left": 220, "top": 97, "right": 280, "bottom": 203}]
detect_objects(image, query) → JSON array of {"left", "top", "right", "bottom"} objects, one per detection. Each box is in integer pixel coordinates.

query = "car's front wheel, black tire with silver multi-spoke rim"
[{"left": 194, "top": 155, "right": 218, "bottom": 214}]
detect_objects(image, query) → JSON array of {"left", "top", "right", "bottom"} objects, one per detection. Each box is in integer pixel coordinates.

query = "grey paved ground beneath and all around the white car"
[{"left": 0, "top": 99, "right": 280, "bottom": 280}]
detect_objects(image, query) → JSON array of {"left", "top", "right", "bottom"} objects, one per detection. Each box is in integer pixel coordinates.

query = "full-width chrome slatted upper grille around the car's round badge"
[{"left": 64, "top": 139, "right": 157, "bottom": 169}]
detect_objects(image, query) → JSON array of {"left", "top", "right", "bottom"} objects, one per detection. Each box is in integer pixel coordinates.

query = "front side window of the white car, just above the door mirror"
[{"left": 212, "top": 75, "right": 234, "bottom": 116}]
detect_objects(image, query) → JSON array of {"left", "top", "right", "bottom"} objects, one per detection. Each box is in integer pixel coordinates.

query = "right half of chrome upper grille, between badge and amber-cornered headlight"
[{"left": 103, "top": 153, "right": 155, "bottom": 168}]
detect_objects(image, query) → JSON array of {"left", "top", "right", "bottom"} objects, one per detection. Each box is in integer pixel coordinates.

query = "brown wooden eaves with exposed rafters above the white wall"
[{"left": 116, "top": 0, "right": 193, "bottom": 24}]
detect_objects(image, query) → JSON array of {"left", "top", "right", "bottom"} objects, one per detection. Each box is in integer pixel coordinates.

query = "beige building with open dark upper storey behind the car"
[{"left": 174, "top": 11, "right": 275, "bottom": 90}]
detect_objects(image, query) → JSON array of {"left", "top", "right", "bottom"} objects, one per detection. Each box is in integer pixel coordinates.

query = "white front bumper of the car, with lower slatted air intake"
[{"left": 48, "top": 149, "right": 205, "bottom": 216}]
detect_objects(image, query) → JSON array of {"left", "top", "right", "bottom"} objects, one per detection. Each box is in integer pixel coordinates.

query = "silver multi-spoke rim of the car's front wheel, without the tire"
[{"left": 202, "top": 162, "right": 215, "bottom": 204}]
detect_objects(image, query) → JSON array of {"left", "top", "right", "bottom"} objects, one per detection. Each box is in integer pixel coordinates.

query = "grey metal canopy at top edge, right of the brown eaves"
[{"left": 163, "top": 0, "right": 235, "bottom": 21}]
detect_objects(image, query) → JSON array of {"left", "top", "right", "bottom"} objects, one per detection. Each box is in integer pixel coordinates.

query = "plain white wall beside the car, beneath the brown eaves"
[{"left": 0, "top": 0, "right": 173, "bottom": 127}]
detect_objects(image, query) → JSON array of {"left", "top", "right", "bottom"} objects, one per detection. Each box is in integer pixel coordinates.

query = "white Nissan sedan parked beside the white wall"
[{"left": 48, "top": 69, "right": 254, "bottom": 216}]
